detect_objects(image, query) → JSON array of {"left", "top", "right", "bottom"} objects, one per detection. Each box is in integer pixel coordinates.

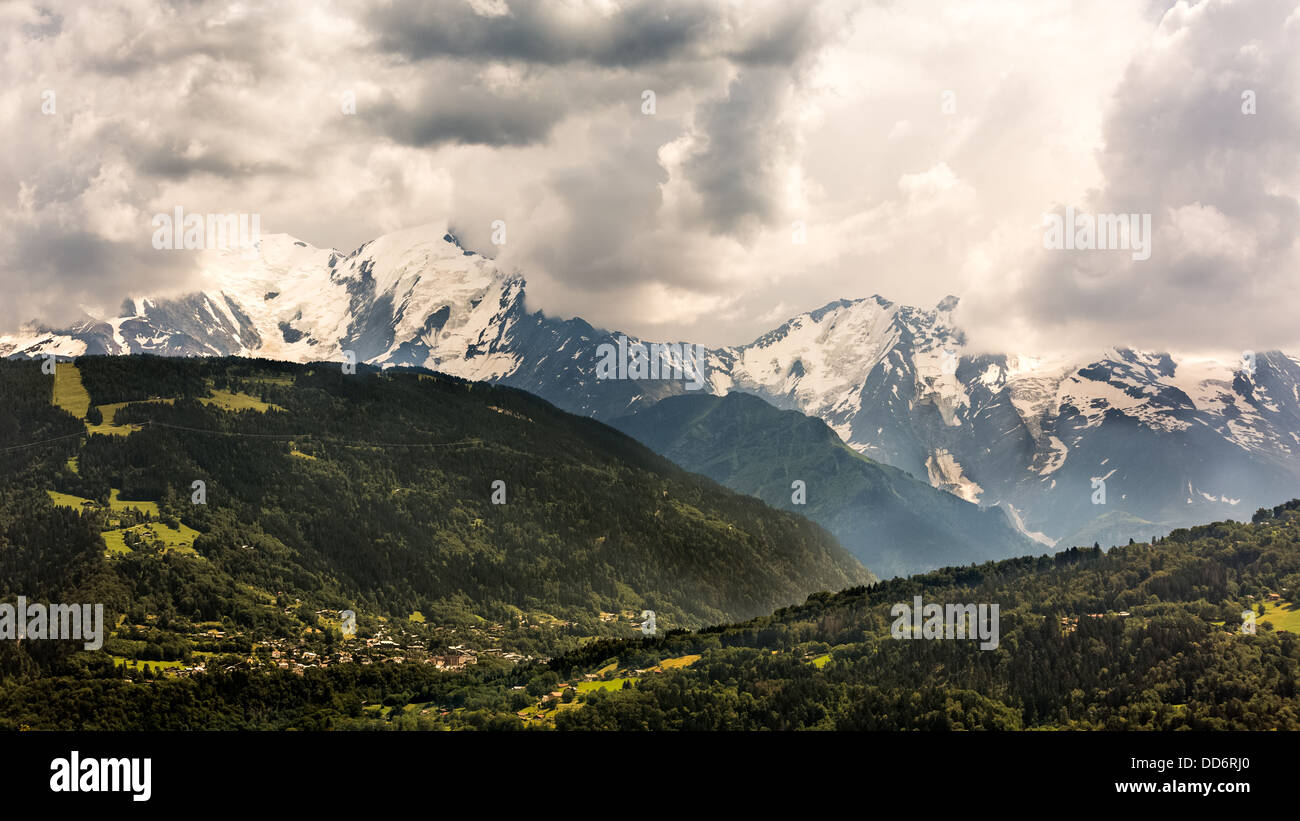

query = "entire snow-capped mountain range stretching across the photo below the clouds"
[{"left": 0, "top": 226, "right": 1300, "bottom": 544}]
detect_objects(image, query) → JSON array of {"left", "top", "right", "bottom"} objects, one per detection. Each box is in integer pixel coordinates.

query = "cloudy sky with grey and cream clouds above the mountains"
[{"left": 0, "top": 0, "right": 1300, "bottom": 355}]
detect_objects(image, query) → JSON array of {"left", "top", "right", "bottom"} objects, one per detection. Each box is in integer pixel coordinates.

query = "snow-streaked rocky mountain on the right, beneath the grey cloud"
[{"left": 719, "top": 296, "right": 1300, "bottom": 544}]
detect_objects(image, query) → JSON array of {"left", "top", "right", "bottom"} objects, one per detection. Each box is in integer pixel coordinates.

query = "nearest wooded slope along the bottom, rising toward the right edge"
[{"left": 0, "top": 488, "right": 1300, "bottom": 730}]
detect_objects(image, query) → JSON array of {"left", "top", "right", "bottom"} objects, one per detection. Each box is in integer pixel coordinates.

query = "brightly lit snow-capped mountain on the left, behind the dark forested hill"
[{"left": 0, "top": 225, "right": 702, "bottom": 416}]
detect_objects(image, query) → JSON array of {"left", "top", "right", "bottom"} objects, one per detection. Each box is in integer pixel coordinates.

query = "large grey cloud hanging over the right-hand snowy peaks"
[{"left": 987, "top": 0, "right": 1300, "bottom": 349}]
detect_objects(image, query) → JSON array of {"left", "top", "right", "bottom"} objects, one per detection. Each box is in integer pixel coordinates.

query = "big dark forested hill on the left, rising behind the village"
[{"left": 0, "top": 356, "right": 872, "bottom": 691}]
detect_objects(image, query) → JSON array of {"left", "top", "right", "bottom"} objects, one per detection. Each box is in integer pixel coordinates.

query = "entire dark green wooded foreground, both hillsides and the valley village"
[{"left": 0, "top": 359, "right": 1300, "bottom": 730}]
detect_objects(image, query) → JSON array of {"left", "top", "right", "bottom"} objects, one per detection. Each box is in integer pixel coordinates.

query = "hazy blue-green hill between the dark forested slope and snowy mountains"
[{"left": 614, "top": 392, "right": 1043, "bottom": 578}]
